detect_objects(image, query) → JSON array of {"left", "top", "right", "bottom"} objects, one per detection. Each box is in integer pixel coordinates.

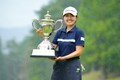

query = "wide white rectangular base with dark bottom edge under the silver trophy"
[{"left": 31, "top": 49, "right": 56, "bottom": 58}]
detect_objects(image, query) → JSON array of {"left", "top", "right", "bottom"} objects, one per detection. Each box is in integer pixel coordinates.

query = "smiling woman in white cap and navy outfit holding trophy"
[{"left": 37, "top": 6, "right": 84, "bottom": 80}]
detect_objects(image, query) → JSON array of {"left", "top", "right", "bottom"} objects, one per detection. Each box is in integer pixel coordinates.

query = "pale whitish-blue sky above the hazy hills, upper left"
[{"left": 0, "top": 0, "right": 50, "bottom": 28}]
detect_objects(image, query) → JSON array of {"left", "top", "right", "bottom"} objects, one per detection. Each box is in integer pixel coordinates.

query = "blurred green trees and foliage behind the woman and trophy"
[{"left": 0, "top": 0, "right": 120, "bottom": 80}]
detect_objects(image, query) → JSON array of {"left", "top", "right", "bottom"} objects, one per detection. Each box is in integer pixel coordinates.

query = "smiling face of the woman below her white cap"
[{"left": 63, "top": 13, "right": 77, "bottom": 27}]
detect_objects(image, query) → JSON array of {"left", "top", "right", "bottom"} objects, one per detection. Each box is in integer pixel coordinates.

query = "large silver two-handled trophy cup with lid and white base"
[{"left": 31, "top": 11, "right": 63, "bottom": 58}]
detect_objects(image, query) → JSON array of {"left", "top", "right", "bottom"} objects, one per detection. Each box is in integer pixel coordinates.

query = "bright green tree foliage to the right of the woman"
[{"left": 78, "top": 0, "right": 120, "bottom": 79}]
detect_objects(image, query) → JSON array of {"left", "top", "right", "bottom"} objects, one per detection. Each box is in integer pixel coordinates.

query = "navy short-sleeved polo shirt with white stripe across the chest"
[{"left": 52, "top": 26, "right": 84, "bottom": 56}]
